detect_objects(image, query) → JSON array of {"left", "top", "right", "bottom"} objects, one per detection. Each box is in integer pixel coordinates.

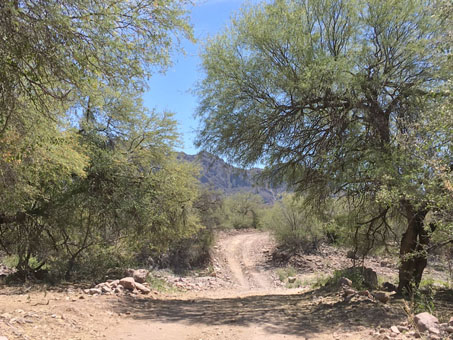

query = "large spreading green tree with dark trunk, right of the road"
[{"left": 198, "top": 0, "right": 453, "bottom": 291}]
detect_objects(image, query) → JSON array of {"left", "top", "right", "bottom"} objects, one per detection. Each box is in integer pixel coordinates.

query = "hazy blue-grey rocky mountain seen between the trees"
[{"left": 178, "top": 151, "right": 285, "bottom": 204}]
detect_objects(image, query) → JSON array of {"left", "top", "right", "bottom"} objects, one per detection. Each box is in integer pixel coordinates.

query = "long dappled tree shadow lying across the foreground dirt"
[{"left": 114, "top": 292, "right": 405, "bottom": 336}]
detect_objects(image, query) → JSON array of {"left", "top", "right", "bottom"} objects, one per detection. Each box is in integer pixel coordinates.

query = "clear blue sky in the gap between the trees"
[{"left": 143, "top": 0, "right": 249, "bottom": 154}]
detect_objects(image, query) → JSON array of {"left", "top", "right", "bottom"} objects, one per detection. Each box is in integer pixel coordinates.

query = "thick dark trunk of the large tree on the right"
[{"left": 398, "top": 204, "right": 430, "bottom": 293}]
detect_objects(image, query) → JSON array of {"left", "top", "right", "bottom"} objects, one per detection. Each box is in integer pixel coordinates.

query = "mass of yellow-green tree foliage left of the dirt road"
[{"left": 0, "top": 0, "right": 201, "bottom": 279}]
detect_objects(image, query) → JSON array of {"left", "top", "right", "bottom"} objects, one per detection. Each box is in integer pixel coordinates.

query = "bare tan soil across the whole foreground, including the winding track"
[{"left": 0, "top": 231, "right": 448, "bottom": 340}]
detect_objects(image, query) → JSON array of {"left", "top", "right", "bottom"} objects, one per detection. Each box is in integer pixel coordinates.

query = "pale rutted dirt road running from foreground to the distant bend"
[{"left": 107, "top": 231, "right": 402, "bottom": 340}]
